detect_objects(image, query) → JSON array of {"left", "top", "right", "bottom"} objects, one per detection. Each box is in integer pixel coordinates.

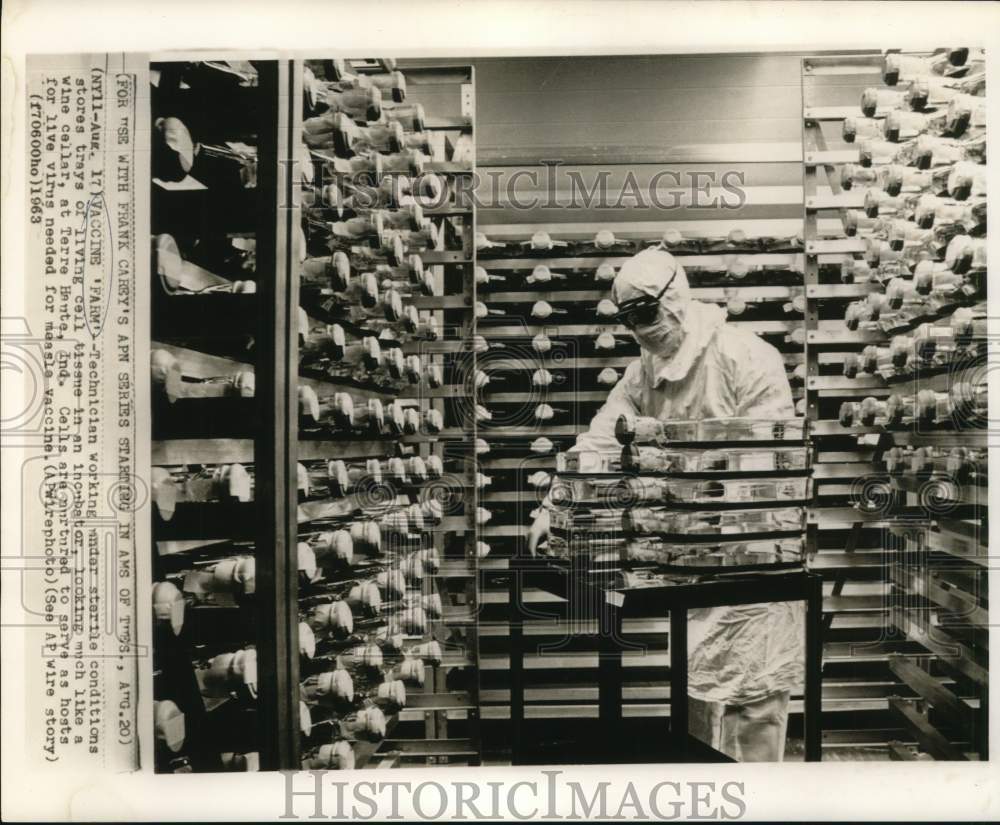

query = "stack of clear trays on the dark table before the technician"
[{"left": 549, "top": 416, "right": 812, "bottom": 575}]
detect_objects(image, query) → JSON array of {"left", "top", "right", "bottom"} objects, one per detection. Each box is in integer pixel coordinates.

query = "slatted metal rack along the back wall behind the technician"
[{"left": 479, "top": 230, "right": 803, "bottom": 740}]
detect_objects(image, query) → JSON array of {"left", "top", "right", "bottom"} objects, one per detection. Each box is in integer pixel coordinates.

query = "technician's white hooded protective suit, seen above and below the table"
[{"left": 573, "top": 249, "right": 804, "bottom": 748}]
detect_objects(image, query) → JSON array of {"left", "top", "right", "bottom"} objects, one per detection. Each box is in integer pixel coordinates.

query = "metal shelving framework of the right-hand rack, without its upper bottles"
[{"left": 802, "top": 55, "right": 988, "bottom": 759}]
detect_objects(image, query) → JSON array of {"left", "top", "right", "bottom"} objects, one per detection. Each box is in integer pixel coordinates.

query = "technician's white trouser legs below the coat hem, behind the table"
[{"left": 688, "top": 690, "right": 789, "bottom": 762}]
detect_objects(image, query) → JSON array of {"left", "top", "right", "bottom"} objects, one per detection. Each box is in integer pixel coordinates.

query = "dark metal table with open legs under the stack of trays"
[{"left": 507, "top": 557, "right": 823, "bottom": 765}]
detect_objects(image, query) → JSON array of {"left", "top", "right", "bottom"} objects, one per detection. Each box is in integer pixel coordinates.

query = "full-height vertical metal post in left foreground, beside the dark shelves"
[{"left": 254, "top": 61, "right": 299, "bottom": 770}]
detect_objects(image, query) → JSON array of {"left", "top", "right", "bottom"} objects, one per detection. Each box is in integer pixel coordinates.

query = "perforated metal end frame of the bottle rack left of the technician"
[{"left": 292, "top": 61, "right": 480, "bottom": 768}]
